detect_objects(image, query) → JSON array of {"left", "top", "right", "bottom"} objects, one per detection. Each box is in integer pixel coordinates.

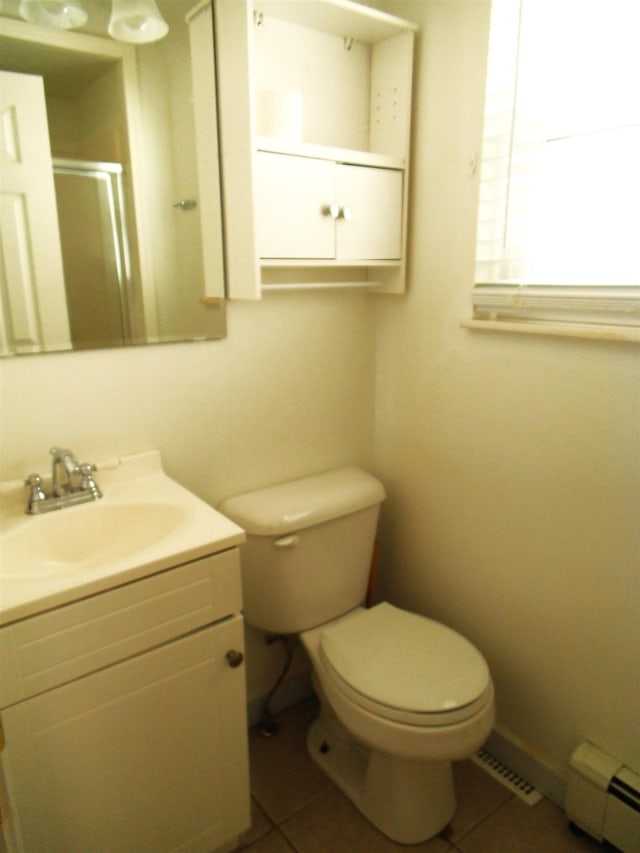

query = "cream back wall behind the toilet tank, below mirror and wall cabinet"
[{"left": 0, "top": 292, "right": 374, "bottom": 700}]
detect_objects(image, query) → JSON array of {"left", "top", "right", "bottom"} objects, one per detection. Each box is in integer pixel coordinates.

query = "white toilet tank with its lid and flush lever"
[{"left": 219, "top": 468, "right": 385, "bottom": 634}]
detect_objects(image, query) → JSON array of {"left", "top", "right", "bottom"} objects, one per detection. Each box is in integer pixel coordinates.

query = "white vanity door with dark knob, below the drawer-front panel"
[{"left": 2, "top": 616, "right": 249, "bottom": 853}]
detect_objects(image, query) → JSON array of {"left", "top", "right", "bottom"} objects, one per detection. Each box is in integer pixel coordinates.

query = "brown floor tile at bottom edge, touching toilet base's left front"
[{"left": 280, "top": 788, "right": 453, "bottom": 853}]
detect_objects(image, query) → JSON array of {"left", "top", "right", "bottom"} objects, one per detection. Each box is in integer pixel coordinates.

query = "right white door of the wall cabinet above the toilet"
[{"left": 336, "top": 164, "right": 403, "bottom": 261}]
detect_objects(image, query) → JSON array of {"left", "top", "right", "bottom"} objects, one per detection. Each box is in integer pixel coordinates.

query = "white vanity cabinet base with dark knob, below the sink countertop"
[{"left": 0, "top": 548, "right": 250, "bottom": 853}]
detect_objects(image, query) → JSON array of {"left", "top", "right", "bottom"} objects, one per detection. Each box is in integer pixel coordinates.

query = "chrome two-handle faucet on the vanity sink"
[{"left": 24, "top": 447, "right": 102, "bottom": 515}]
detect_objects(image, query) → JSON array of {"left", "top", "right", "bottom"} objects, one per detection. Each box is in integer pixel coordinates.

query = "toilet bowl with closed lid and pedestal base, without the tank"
[{"left": 301, "top": 604, "right": 494, "bottom": 844}]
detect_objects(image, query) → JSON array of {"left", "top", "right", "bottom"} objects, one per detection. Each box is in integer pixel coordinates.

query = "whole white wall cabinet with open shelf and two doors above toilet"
[{"left": 215, "top": 0, "right": 416, "bottom": 299}]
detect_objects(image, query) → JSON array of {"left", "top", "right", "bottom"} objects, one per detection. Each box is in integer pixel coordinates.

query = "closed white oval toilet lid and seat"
[{"left": 320, "top": 602, "right": 491, "bottom": 725}]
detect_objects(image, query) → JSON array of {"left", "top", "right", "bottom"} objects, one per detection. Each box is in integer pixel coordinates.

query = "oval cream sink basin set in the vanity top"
[{"left": 2, "top": 501, "right": 188, "bottom": 581}]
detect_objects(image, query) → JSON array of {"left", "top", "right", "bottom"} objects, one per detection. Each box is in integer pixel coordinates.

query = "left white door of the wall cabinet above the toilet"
[{"left": 255, "top": 151, "right": 335, "bottom": 259}]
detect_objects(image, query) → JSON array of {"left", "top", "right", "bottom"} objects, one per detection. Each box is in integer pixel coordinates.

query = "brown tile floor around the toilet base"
[{"left": 241, "top": 699, "right": 602, "bottom": 853}]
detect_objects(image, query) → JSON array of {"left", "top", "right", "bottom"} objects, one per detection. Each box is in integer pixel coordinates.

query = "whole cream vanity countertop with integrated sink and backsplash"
[{"left": 0, "top": 450, "right": 245, "bottom": 625}]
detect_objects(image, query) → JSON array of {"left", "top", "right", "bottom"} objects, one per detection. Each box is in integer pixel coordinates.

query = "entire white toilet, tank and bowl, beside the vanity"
[{"left": 220, "top": 467, "right": 495, "bottom": 844}]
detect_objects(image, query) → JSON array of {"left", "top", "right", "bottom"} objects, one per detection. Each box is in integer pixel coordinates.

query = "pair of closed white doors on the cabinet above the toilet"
[{"left": 255, "top": 151, "right": 403, "bottom": 263}]
